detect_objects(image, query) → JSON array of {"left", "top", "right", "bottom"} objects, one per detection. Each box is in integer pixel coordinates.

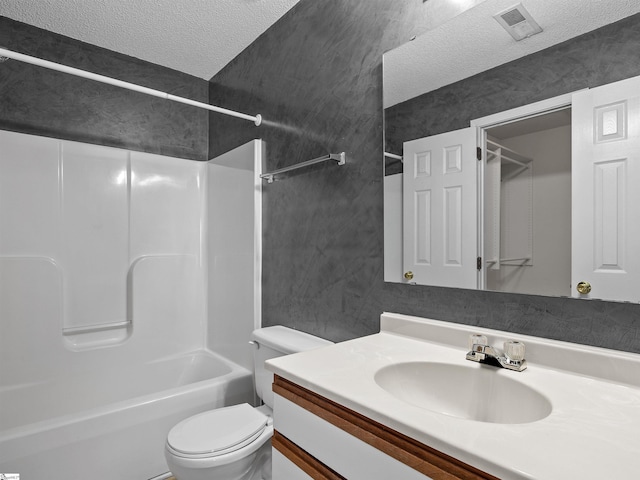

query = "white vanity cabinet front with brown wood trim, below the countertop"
[{"left": 272, "top": 376, "right": 496, "bottom": 480}]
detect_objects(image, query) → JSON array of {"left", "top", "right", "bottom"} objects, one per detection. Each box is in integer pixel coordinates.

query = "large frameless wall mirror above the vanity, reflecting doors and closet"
[{"left": 383, "top": 0, "right": 640, "bottom": 302}]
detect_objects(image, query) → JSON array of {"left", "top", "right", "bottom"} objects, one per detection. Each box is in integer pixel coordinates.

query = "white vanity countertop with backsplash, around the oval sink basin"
[{"left": 267, "top": 314, "right": 640, "bottom": 480}]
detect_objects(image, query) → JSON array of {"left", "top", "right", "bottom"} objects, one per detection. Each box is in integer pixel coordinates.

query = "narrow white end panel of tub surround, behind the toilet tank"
[{"left": 207, "top": 140, "right": 263, "bottom": 370}]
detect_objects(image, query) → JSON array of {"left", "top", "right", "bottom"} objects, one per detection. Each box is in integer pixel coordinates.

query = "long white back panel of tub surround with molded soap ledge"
[{"left": 0, "top": 131, "right": 206, "bottom": 387}]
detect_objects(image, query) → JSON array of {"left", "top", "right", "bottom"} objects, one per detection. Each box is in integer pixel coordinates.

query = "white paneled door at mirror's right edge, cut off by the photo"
[{"left": 571, "top": 77, "right": 640, "bottom": 302}]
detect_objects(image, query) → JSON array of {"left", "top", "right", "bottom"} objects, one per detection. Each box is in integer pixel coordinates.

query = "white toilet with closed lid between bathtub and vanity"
[{"left": 164, "top": 326, "right": 332, "bottom": 480}]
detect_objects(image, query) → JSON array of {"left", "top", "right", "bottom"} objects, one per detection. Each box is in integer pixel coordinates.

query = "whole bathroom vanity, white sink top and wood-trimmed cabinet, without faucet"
[{"left": 267, "top": 313, "right": 640, "bottom": 480}]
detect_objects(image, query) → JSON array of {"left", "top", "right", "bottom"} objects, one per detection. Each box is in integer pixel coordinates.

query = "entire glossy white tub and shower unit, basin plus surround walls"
[{"left": 0, "top": 131, "right": 261, "bottom": 480}]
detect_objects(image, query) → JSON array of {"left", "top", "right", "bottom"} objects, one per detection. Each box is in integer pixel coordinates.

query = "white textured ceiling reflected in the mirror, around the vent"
[{"left": 383, "top": 0, "right": 640, "bottom": 108}]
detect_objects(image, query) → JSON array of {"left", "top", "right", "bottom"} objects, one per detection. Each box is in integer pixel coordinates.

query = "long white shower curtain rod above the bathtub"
[{"left": 0, "top": 47, "right": 262, "bottom": 126}]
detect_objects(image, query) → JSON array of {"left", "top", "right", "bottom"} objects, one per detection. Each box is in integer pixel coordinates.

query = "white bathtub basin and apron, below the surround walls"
[{"left": 0, "top": 350, "right": 254, "bottom": 480}]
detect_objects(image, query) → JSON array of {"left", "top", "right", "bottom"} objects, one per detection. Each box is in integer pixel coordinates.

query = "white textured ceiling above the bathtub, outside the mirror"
[{"left": 0, "top": 0, "right": 299, "bottom": 80}]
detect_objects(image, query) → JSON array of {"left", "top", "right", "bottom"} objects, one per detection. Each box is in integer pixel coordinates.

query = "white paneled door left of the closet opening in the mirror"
[{"left": 403, "top": 128, "right": 478, "bottom": 288}]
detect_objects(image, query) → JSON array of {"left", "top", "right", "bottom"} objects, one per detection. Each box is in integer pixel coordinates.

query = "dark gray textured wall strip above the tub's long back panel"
[{"left": 0, "top": 17, "right": 209, "bottom": 160}]
